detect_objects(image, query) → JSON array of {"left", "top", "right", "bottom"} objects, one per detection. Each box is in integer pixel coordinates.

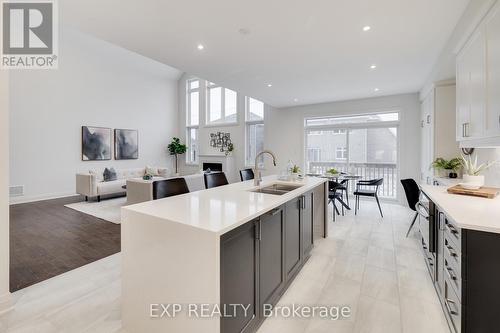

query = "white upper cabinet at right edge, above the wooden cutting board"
[{"left": 456, "top": 2, "right": 500, "bottom": 147}]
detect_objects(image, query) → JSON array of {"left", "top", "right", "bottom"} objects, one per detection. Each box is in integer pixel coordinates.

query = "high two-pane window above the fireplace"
[{"left": 206, "top": 82, "right": 238, "bottom": 125}]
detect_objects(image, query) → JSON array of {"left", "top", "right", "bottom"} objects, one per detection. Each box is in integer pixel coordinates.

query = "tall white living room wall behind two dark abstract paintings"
[{"left": 10, "top": 27, "right": 180, "bottom": 201}]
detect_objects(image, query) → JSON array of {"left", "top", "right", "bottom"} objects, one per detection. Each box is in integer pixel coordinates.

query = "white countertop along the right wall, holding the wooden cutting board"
[{"left": 421, "top": 185, "right": 500, "bottom": 234}]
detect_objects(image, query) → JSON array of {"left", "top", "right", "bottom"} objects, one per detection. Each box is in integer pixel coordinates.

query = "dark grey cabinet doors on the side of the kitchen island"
[{"left": 220, "top": 186, "right": 324, "bottom": 333}]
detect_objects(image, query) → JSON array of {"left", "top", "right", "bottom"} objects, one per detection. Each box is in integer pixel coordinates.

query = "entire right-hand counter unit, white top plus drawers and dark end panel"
[{"left": 419, "top": 185, "right": 500, "bottom": 333}]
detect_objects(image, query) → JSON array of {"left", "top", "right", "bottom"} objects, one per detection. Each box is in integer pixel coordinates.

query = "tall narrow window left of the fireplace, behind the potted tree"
[{"left": 186, "top": 79, "right": 200, "bottom": 164}]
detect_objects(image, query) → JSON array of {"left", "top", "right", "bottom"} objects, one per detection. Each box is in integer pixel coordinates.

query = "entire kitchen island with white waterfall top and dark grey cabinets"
[{"left": 122, "top": 176, "right": 328, "bottom": 333}]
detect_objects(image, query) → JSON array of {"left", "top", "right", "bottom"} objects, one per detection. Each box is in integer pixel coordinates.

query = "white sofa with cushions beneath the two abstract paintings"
[{"left": 76, "top": 168, "right": 169, "bottom": 201}]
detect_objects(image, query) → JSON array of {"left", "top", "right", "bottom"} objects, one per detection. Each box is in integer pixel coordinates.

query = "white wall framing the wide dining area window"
[{"left": 265, "top": 93, "right": 420, "bottom": 202}]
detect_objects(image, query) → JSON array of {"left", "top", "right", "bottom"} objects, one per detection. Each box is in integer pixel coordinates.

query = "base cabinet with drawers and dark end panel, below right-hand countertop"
[{"left": 422, "top": 197, "right": 500, "bottom": 333}]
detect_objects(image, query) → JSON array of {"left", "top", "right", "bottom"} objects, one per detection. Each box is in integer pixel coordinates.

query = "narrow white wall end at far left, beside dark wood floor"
[{"left": 0, "top": 70, "right": 11, "bottom": 313}]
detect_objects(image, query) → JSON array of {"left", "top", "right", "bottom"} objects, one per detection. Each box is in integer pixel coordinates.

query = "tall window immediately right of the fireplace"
[{"left": 245, "top": 97, "right": 264, "bottom": 166}]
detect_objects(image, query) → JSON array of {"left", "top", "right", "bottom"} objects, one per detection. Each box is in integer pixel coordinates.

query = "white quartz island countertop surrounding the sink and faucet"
[{"left": 122, "top": 176, "right": 327, "bottom": 235}]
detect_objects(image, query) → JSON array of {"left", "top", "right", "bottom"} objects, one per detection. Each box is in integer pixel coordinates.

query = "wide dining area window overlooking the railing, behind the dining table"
[{"left": 305, "top": 112, "right": 399, "bottom": 199}]
